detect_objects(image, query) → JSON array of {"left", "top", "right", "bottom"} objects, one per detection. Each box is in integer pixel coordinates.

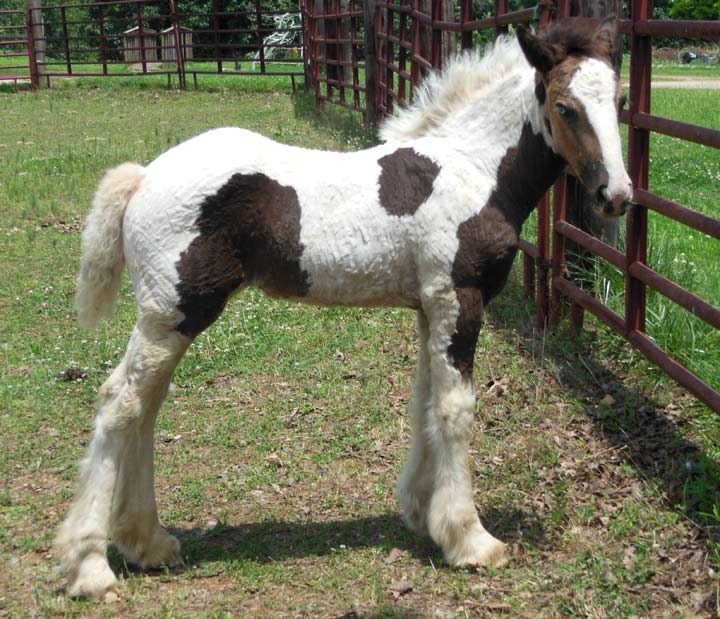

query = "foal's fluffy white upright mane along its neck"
[{"left": 380, "top": 37, "right": 530, "bottom": 142}]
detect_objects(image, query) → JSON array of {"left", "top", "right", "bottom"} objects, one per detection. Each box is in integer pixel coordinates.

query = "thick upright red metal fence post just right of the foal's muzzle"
[{"left": 625, "top": 0, "right": 653, "bottom": 334}]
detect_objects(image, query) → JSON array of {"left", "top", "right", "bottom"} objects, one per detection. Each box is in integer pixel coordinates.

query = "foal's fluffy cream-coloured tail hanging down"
[{"left": 76, "top": 163, "right": 145, "bottom": 327}]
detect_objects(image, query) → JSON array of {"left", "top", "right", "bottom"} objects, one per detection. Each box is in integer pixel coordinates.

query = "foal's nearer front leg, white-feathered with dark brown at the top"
[{"left": 426, "top": 288, "right": 505, "bottom": 567}]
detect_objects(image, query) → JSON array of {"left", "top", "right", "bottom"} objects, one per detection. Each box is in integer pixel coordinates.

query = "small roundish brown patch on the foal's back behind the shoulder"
[{"left": 378, "top": 148, "right": 440, "bottom": 217}]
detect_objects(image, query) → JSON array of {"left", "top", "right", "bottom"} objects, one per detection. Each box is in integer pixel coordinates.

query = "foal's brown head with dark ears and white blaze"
[{"left": 518, "top": 19, "right": 632, "bottom": 217}]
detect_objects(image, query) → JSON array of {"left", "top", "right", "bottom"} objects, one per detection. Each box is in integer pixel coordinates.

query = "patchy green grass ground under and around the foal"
[{"left": 0, "top": 78, "right": 720, "bottom": 618}]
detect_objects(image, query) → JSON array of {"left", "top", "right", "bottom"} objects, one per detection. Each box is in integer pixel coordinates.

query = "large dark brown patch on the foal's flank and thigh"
[{"left": 176, "top": 174, "right": 309, "bottom": 337}]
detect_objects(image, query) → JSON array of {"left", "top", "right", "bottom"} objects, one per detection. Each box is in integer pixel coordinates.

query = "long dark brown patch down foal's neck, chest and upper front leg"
[{"left": 448, "top": 124, "right": 564, "bottom": 379}]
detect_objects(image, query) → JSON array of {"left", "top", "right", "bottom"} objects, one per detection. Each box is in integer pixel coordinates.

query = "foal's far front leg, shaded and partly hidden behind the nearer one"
[{"left": 397, "top": 310, "right": 433, "bottom": 533}]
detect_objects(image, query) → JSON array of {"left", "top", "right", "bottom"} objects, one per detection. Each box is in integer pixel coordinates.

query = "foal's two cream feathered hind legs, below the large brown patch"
[{"left": 55, "top": 317, "right": 190, "bottom": 596}]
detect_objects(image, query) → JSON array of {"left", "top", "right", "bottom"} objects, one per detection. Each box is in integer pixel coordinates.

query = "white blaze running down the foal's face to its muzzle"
[{"left": 570, "top": 58, "right": 632, "bottom": 205}]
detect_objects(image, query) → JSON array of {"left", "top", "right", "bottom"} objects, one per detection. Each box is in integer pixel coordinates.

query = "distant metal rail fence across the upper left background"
[{"left": 0, "top": 0, "right": 306, "bottom": 88}]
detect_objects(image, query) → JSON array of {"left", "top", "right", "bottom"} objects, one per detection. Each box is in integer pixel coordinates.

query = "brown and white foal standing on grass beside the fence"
[{"left": 56, "top": 21, "right": 632, "bottom": 596}]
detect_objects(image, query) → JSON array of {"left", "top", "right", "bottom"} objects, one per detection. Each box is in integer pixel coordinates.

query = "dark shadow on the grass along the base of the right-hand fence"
[{"left": 488, "top": 282, "right": 720, "bottom": 548}]
